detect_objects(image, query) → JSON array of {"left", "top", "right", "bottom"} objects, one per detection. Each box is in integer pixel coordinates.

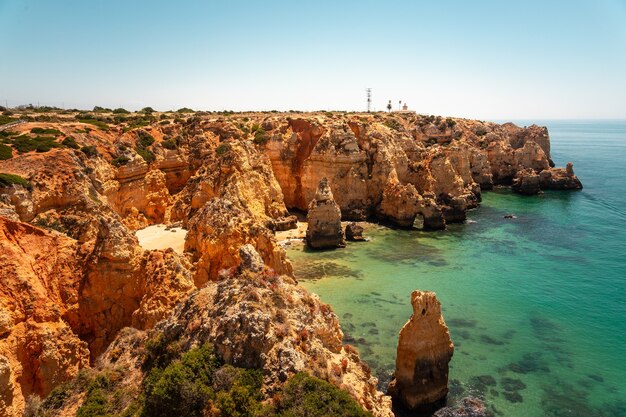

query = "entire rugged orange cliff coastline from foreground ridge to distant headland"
[{"left": 0, "top": 109, "right": 582, "bottom": 416}]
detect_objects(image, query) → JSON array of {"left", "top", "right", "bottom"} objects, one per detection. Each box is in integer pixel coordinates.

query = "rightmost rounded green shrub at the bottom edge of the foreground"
[{"left": 277, "top": 373, "right": 372, "bottom": 417}]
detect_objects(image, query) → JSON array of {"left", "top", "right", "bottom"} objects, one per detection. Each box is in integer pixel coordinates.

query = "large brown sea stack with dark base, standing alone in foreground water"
[{"left": 388, "top": 291, "right": 454, "bottom": 412}]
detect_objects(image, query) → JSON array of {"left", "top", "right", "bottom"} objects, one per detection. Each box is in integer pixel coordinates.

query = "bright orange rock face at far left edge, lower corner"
[{"left": 0, "top": 217, "right": 89, "bottom": 416}]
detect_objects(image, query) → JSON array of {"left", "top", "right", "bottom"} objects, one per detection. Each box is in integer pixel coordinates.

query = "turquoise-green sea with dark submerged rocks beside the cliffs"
[{"left": 288, "top": 121, "right": 626, "bottom": 417}]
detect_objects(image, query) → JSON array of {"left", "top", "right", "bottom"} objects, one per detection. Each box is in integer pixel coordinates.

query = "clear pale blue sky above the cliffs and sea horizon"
[{"left": 0, "top": 0, "right": 626, "bottom": 119}]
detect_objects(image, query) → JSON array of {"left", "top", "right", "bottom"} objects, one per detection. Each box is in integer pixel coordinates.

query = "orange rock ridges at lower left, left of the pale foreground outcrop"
[{"left": 0, "top": 217, "right": 195, "bottom": 415}]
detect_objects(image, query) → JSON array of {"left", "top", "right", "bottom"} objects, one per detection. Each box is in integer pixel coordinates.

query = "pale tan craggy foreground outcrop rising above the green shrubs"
[{"left": 79, "top": 268, "right": 393, "bottom": 417}]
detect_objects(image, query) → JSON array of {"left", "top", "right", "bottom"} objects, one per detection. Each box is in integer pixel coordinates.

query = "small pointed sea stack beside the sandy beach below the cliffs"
[{"left": 306, "top": 177, "right": 346, "bottom": 249}]
